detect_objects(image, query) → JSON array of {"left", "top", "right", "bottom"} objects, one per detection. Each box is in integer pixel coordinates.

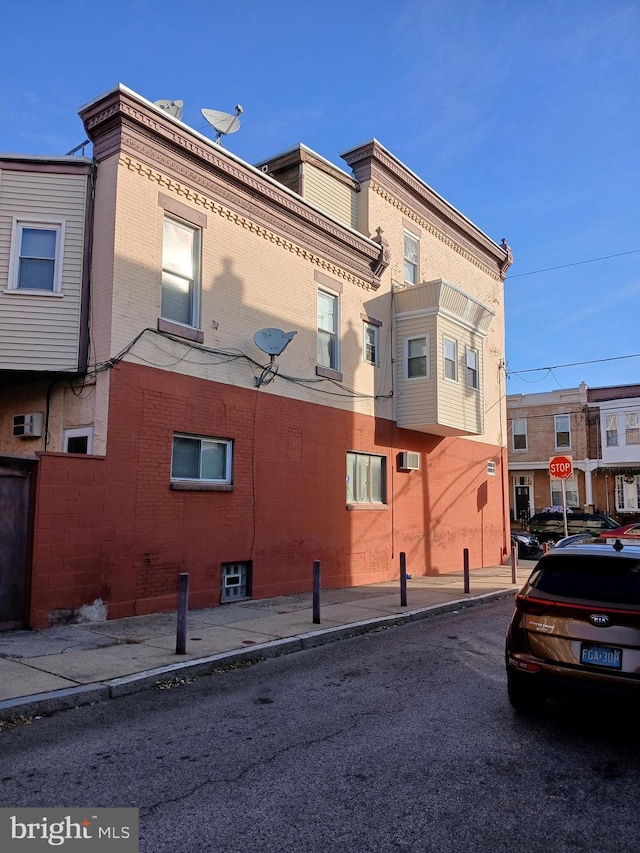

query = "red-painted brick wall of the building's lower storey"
[{"left": 31, "top": 363, "right": 509, "bottom": 627}]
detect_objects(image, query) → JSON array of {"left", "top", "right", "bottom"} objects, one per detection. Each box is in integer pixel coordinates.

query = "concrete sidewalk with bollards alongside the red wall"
[{"left": 0, "top": 561, "right": 535, "bottom": 720}]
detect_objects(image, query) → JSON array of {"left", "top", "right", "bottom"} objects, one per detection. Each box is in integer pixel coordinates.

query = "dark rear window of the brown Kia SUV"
[{"left": 529, "top": 553, "right": 640, "bottom": 605}]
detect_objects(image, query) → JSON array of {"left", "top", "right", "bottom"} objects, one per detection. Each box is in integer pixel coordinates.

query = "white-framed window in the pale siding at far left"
[{"left": 8, "top": 219, "right": 64, "bottom": 293}]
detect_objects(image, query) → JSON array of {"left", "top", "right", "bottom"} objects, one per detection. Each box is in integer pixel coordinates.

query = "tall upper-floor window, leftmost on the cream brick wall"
[{"left": 160, "top": 216, "right": 200, "bottom": 328}]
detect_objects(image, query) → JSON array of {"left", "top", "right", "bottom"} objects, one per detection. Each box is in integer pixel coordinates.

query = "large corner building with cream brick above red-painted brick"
[{"left": 0, "top": 86, "right": 511, "bottom": 627}]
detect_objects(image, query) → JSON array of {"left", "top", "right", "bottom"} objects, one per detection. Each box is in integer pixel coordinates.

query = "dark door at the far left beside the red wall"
[{"left": 0, "top": 458, "right": 33, "bottom": 631}]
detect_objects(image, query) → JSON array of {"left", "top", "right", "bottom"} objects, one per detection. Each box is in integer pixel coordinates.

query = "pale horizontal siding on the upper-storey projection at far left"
[{"left": 0, "top": 169, "right": 87, "bottom": 371}]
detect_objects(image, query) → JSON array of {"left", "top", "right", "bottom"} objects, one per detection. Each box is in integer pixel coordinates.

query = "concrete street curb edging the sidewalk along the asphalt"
[{"left": 0, "top": 588, "right": 517, "bottom": 721}]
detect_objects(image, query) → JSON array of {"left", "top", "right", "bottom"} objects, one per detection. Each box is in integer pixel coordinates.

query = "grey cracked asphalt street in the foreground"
[{"left": 0, "top": 600, "right": 640, "bottom": 853}]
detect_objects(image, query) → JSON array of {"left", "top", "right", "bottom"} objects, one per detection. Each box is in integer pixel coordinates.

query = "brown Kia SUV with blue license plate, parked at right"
[{"left": 505, "top": 541, "right": 640, "bottom": 713}]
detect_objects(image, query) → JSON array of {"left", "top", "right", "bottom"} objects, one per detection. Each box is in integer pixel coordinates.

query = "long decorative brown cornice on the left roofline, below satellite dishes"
[{"left": 81, "top": 88, "right": 380, "bottom": 289}]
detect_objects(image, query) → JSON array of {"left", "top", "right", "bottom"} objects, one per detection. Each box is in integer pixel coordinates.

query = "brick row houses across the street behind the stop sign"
[{"left": 507, "top": 383, "right": 640, "bottom": 524}]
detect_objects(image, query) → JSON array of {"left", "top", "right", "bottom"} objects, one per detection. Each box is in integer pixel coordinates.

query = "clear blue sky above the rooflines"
[{"left": 0, "top": 0, "right": 640, "bottom": 394}]
